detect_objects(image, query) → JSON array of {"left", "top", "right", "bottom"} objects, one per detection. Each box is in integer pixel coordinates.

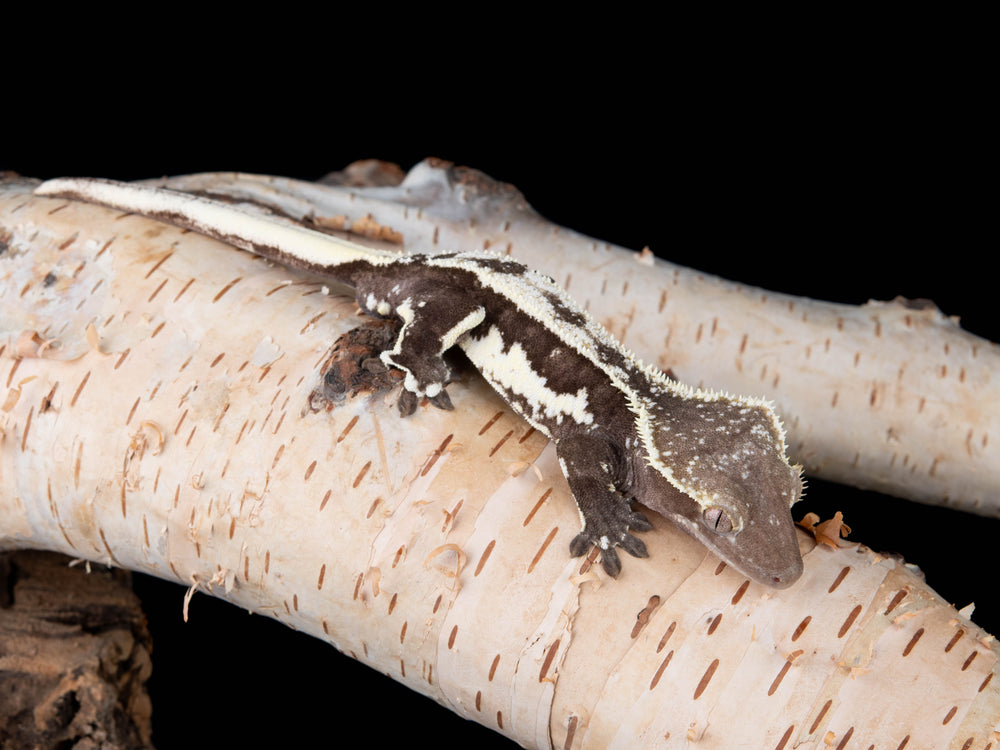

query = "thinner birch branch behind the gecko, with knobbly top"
[{"left": 143, "top": 161, "right": 1000, "bottom": 516}]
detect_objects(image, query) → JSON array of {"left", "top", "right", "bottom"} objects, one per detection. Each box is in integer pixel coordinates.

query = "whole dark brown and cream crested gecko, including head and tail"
[{"left": 36, "top": 179, "right": 802, "bottom": 588}]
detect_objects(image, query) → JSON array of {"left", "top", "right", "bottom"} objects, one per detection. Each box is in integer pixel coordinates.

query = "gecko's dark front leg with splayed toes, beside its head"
[{"left": 556, "top": 436, "right": 653, "bottom": 578}]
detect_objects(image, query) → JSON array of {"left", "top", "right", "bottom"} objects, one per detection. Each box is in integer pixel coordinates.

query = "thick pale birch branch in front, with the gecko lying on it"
[{"left": 0, "top": 182, "right": 1000, "bottom": 748}]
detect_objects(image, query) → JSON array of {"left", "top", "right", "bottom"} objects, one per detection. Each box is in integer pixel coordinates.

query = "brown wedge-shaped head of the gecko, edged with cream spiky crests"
[{"left": 640, "top": 391, "right": 802, "bottom": 588}]
